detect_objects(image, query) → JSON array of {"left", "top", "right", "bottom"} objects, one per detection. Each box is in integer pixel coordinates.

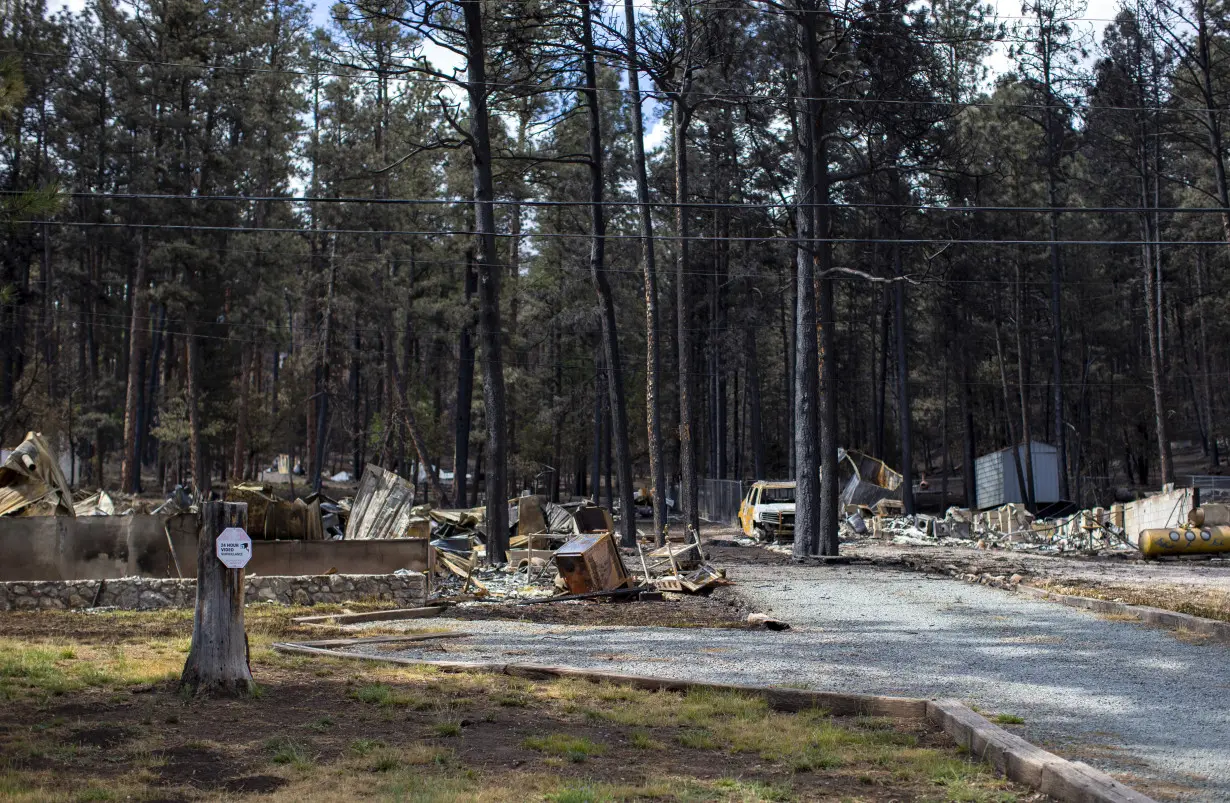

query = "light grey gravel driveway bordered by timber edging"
[{"left": 361, "top": 566, "right": 1230, "bottom": 801}]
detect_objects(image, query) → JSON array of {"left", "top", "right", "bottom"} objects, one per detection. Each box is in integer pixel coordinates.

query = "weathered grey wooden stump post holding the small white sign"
[{"left": 180, "top": 502, "right": 255, "bottom": 696}]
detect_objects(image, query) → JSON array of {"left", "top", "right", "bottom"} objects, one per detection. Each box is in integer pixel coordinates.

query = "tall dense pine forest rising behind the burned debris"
[{"left": 0, "top": 0, "right": 1230, "bottom": 526}]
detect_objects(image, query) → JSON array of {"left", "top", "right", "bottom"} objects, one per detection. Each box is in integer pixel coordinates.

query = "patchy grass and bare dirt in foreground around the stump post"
[{"left": 0, "top": 609, "right": 1038, "bottom": 803}]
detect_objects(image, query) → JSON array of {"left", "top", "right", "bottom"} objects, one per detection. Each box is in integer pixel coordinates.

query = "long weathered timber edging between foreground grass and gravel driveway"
[{"left": 273, "top": 642, "right": 1155, "bottom": 803}]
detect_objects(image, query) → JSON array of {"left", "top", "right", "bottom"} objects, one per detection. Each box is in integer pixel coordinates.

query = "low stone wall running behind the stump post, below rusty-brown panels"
[{"left": 0, "top": 572, "right": 427, "bottom": 611}]
